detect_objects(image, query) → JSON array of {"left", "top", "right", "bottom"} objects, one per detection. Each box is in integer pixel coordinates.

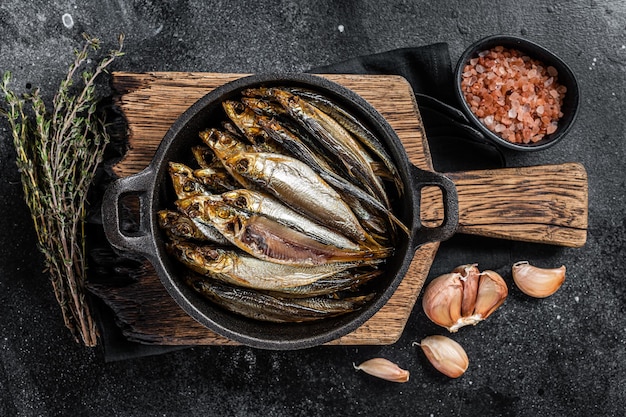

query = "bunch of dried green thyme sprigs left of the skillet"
[{"left": 0, "top": 35, "right": 124, "bottom": 346}]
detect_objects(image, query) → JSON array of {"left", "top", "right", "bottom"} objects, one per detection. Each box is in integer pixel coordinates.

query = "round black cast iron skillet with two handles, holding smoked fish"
[{"left": 102, "top": 74, "right": 458, "bottom": 350}]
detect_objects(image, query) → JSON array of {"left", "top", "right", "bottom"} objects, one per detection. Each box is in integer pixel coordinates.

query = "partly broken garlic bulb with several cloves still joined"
[{"left": 422, "top": 264, "right": 509, "bottom": 332}]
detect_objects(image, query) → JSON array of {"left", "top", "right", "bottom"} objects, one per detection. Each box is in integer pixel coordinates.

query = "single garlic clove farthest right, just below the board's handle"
[{"left": 512, "top": 261, "right": 566, "bottom": 298}]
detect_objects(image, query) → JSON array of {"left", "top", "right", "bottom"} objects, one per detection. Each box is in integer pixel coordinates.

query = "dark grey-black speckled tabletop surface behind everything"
[{"left": 0, "top": 0, "right": 626, "bottom": 417}]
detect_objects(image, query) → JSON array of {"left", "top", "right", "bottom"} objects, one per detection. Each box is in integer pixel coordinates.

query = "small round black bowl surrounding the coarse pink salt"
[{"left": 454, "top": 35, "right": 580, "bottom": 151}]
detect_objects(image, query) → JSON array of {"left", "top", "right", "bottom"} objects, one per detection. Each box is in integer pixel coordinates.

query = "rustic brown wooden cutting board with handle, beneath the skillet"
[{"left": 90, "top": 72, "right": 587, "bottom": 345}]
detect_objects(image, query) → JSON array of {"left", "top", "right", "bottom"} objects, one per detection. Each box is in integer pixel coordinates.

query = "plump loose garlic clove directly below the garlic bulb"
[{"left": 414, "top": 335, "right": 469, "bottom": 378}]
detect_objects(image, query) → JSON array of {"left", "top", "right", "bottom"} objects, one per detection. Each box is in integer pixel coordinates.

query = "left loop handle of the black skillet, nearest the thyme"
[{"left": 102, "top": 167, "right": 154, "bottom": 256}]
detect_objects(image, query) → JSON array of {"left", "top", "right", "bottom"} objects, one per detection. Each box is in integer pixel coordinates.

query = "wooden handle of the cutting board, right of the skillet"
[{"left": 421, "top": 163, "right": 588, "bottom": 247}]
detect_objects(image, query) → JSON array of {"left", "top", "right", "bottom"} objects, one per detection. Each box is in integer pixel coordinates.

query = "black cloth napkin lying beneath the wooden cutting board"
[{"left": 90, "top": 43, "right": 506, "bottom": 361}]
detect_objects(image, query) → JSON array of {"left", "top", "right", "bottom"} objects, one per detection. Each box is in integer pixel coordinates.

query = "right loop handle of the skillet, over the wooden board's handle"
[{"left": 411, "top": 165, "right": 459, "bottom": 250}]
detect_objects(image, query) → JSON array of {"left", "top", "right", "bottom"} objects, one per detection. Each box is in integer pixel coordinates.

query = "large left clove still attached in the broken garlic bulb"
[{"left": 422, "top": 272, "right": 463, "bottom": 331}]
